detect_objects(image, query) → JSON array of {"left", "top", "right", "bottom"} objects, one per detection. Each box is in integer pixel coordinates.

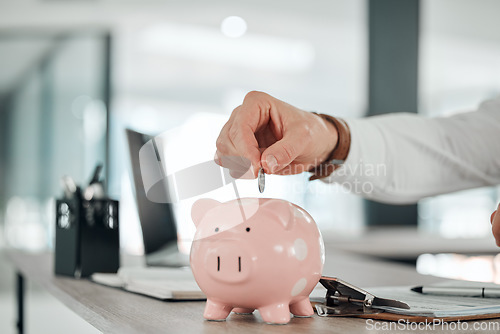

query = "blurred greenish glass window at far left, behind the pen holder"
[{"left": 0, "top": 31, "right": 107, "bottom": 250}]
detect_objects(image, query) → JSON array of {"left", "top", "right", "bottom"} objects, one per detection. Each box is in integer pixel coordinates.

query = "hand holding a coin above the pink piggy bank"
[{"left": 215, "top": 92, "right": 338, "bottom": 178}]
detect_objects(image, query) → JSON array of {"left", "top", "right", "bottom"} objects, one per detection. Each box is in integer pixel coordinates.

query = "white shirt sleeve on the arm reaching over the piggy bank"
[{"left": 324, "top": 97, "right": 500, "bottom": 204}]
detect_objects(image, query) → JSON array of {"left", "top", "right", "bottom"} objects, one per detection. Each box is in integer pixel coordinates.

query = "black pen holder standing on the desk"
[{"left": 54, "top": 195, "right": 120, "bottom": 278}]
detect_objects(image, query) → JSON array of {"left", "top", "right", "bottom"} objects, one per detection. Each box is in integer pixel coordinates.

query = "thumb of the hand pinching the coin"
[{"left": 261, "top": 135, "right": 306, "bottom": 174}]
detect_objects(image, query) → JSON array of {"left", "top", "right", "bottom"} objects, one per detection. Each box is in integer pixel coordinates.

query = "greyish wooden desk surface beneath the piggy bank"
[{"left": 8, "top": 245, "right": 495, "bottom": 333}]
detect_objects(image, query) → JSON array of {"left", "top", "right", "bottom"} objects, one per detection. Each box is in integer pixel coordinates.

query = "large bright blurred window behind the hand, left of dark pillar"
[{"left": 110, "top": 0, "right": 367, "bottom": 253}]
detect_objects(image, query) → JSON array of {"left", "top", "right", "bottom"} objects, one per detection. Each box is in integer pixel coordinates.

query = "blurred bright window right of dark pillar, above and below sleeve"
[{"left": 419, "top": 0, "right": 500, "bottom": 238}]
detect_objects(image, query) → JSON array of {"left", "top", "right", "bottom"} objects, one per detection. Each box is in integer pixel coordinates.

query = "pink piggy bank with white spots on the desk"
[{"left": 190, "top": 198, "right": 325, "bottom": 324}]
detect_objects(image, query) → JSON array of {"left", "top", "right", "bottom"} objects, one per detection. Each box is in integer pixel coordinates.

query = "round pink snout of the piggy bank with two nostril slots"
[{"left": 204, "top": 242, "right": 252, "bottom": 283}]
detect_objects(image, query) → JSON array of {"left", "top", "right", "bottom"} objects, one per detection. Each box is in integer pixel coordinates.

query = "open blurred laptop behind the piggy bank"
[{"left": 126, "top": 129, "right": 189, "bottom": 267}]
